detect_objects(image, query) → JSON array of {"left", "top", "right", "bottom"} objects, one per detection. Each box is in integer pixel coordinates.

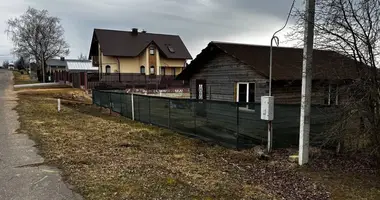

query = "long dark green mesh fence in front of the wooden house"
[{"left": 92, "top": 90, "right": 333, "bottom": 149}]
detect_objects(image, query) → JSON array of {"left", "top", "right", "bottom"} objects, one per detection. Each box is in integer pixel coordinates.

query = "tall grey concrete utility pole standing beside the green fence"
[{"left": 298, "top": 0, "right": 315, "bottom": 165}]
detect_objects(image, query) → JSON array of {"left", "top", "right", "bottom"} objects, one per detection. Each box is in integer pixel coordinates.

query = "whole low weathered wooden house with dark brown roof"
[{"left": 177, "top": 42, "right": 359, "bottom": 105}]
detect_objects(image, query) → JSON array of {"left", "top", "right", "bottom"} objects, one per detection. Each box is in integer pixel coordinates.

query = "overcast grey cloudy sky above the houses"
[{"left": 0, "top": 0, "right": 302, "bottom": 62}]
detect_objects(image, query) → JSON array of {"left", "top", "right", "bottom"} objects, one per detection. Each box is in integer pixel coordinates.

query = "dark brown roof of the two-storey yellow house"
[{"left": 90, "top": 29, "right": 192, "bottom": 59}]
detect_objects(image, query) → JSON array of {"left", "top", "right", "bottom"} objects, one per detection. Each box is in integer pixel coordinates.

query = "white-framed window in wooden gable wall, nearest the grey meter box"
[{"left": 236, "top": 83, "right": 256, "bottom": 109}]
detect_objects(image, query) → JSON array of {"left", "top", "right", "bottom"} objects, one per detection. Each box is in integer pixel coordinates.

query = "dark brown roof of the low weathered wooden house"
[{"left": 178, "top": 42, "right": 358, "bottom": 80}]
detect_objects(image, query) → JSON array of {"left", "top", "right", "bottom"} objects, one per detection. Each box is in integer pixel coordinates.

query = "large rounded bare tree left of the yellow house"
[{"left": 6, "top": 7, "right": 69, "bottom": 82}]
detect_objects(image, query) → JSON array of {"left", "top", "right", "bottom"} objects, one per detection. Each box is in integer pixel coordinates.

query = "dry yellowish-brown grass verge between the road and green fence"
[{"left": 16, "top": 88, "right": 380, "bottom": 200}]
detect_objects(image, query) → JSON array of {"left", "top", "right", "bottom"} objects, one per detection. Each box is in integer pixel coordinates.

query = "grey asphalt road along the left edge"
[{"left": 0, "top": 69, "right": 82, "bottom": 200}]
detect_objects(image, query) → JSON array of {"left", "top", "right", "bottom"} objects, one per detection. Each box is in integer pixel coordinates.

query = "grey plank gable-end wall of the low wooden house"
[{"left": 190, "top": 52, "right": 268, "bottom": 102}]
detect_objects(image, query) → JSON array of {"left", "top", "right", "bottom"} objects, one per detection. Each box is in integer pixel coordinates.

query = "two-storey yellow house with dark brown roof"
[{"left": 89, "top": 28, "right": 192, "bottom": 76}]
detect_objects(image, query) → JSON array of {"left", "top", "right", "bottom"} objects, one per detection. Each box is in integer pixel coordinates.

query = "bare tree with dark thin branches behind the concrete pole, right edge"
[{"left": 288, "top": 0, "right": 380, "bottom": 155}]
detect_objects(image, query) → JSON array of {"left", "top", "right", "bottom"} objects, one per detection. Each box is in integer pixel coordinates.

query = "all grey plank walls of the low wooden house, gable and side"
[{"left": 190, "top": 52, "right": 342, "bottom": 105}]
